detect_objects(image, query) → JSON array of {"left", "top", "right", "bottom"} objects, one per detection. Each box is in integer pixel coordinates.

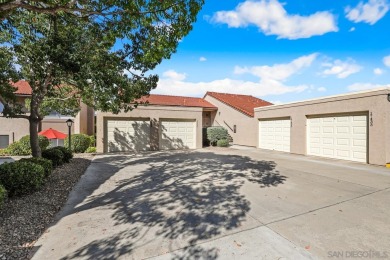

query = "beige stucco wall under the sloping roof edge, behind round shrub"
[{"left": 205, "top": 95, "right": 258, "bottom": 146}]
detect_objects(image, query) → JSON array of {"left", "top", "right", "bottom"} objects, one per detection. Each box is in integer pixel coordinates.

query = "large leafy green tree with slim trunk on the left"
[{"left": 0, "top": 0, "right": 203, "bottom": 157}]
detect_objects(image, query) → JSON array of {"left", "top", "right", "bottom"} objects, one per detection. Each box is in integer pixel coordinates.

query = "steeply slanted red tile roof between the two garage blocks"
[{"left": 205, "top": 92, "right": 273, "bottom": 117}]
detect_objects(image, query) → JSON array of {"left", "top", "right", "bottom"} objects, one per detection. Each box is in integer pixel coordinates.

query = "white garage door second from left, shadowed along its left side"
[{"left": 160, "top": 119, "right": 196, "bottom": 150}]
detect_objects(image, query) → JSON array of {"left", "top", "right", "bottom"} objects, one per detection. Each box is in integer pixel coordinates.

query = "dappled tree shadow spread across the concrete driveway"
[{"left": 63, "top": 151, "right": 286, "bottom": 259}]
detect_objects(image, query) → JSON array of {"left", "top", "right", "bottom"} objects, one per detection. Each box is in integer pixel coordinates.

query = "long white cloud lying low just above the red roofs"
[{"left": 153, "top": 54, "right": 317, "bottom": 97}]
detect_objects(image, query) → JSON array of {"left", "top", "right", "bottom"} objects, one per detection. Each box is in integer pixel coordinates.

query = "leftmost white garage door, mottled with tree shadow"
[{"left": 107, "top": 119, "right": 150, "bottom": 152}]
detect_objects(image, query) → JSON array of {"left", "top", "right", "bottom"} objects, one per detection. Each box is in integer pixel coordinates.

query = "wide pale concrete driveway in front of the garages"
[{"left": 34, "top": 149, "right": 390, "bottom": 259}]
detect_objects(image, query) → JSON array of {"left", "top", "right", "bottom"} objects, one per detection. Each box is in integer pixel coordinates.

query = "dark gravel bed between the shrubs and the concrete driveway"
[{"left": 0, "top": 154, "right": 93, "bottom": 260}]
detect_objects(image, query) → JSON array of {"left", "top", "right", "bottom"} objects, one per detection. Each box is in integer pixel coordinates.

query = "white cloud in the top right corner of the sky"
[{"left": 345, "top": 0, "right": 390, "bottom": 25}]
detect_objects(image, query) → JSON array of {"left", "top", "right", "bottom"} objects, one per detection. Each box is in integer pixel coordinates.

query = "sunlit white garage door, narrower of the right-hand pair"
[{"left": 259, "top": 119, "right": 291, "bottom": 152}]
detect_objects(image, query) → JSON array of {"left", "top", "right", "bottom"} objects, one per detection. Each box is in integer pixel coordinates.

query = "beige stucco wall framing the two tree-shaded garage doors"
[{"left": 96, "top": 105, "right": 203, "bottom": 152}]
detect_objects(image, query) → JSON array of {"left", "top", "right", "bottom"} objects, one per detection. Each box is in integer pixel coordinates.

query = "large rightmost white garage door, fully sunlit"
[{"left": 307, "top": 115, "right": 367, "bottom": 162}]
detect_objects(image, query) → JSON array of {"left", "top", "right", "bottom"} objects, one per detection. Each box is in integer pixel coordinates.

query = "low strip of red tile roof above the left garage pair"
[{"left": 137, "top": 94, "right": 217, "bottom": 109}]
